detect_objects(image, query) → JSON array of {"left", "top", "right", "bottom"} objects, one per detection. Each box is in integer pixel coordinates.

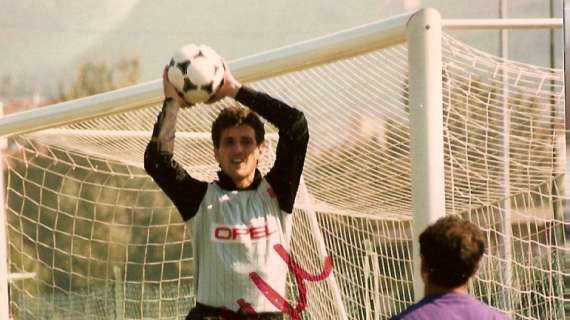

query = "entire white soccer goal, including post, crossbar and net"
[{"left": 0, "top": 9, "right": 568, "bottom": 319}]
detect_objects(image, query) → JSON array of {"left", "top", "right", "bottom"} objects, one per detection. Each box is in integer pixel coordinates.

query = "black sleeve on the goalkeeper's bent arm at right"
[{"left": 236, "top": 86, "right": 309, "bottom": 213}]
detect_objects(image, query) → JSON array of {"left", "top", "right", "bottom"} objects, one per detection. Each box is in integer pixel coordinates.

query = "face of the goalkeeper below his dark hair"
[{"left": 214, "top": 125, "right": 265, "bottom": 188}]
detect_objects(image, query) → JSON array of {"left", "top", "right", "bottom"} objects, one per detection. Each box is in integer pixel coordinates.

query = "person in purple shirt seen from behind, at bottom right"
[{"left": 392, "top": 216, "right": 509, "bottom": 320}]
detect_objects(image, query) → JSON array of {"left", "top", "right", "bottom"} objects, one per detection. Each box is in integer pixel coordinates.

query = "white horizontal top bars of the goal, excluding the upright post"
[{"left": 0, "top": 13, "right": 562, "bottom": 136}]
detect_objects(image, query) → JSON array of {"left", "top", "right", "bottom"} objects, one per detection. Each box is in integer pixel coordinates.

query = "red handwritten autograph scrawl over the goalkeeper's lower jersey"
[{"left": 220, "top": 244, "right": 333, "bottom": 320}]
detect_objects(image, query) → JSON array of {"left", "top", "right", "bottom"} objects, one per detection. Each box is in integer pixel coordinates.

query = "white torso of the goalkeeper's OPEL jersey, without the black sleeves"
[{"left": 191, "top": 179, "right": 292, "bottom": 312}]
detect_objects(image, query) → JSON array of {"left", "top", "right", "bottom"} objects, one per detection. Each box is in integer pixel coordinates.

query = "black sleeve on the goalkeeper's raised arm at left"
[{"left": 144, "top": 99, "right": 208, "bottom": 221}]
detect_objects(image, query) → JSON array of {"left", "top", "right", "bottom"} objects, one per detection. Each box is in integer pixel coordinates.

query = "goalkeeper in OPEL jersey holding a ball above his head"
[{"left": 144, "top": 66, "right": 309, "bottom": 320}]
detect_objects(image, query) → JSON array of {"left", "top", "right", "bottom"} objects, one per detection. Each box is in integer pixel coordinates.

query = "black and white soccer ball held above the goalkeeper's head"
[{"left": 167, "top": 44, "right": 224, "bottom": 104}]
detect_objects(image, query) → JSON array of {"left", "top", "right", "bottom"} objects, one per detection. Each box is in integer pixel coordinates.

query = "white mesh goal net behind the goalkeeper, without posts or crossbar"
[{"left": 4, "top": 11, "right": 569, "bottom": 320}]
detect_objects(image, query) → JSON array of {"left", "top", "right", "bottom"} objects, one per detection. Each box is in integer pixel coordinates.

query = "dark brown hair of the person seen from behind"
[{"left": 420, "top": 216, "right": 485, "bottom": 289}]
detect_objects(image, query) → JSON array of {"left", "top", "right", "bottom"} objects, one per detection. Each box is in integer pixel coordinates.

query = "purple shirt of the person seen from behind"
[{"left": 392, "top": 292, "right": 510, "bottom": 320}]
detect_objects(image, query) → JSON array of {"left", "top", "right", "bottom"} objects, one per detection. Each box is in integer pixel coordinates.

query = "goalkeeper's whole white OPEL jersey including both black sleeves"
[{"left": 144, "top": 86, "right": 309, "bottom": 313}]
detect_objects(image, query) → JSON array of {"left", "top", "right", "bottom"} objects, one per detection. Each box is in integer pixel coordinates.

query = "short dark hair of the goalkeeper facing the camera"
[{"left": 212, "top": 106, "right": 265, "bottom": 149}]
